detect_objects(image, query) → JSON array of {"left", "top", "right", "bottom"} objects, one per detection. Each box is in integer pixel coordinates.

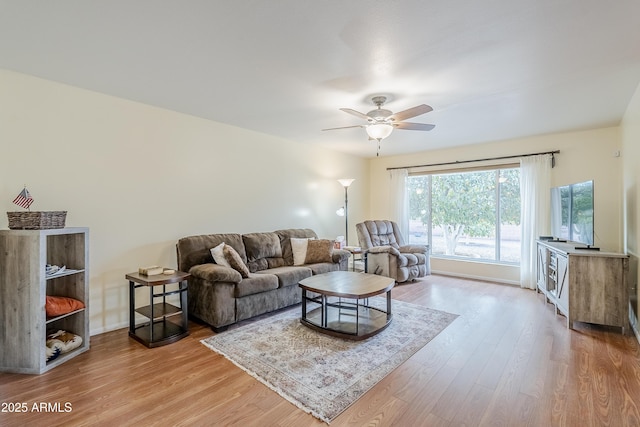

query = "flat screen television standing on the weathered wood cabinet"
[{"left": 551, "top": 181, "right": 594, "bottom": 247}]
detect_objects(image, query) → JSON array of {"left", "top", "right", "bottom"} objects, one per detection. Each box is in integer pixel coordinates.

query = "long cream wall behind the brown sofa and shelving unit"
[{"left": 0, "top": 70, "right": 368, "bottom": 334}]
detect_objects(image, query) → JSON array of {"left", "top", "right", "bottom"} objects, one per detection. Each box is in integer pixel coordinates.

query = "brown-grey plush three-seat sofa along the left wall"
[{"left": 176, "top": 229, "right": 350, "bottom": 331}]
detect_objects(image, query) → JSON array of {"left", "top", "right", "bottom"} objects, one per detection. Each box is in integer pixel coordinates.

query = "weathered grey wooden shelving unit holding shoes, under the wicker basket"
[{"left": 0, "top": 227, "right": 89, "bottom": 374}]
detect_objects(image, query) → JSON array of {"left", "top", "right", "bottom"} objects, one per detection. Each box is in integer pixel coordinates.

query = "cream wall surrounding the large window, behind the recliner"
[{"left": 369, "top": 127, "right": 623, "bottom": 284}]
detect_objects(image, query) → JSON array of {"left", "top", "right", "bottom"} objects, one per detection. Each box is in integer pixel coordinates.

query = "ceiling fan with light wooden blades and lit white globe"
[{"left": 322, "top": 96, "right": 435, "bottom": 155}]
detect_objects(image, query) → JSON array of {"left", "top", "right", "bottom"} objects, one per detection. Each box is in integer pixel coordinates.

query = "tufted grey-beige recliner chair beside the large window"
[{"left": 356, "top": 220, "right": 431, "bottom": 283}]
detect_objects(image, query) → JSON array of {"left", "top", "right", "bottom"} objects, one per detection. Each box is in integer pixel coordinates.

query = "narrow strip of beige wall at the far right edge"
[{"left": 620, "top": 82, "right": 640, "bottom": 340}]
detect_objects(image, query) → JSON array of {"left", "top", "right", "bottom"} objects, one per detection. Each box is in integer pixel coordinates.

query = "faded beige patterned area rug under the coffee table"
[{"left": 201, "top": 297, "right": 457, "bottom": 424}]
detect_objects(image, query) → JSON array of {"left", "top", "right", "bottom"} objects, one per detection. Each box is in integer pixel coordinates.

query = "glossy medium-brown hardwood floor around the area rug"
[{"left": 0, "top": 275, "right": 640, "bottom": 427}]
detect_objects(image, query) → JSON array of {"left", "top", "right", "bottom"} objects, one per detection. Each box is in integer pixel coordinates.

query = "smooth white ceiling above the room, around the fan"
[{"left": 0, "top": 0, "right": 640, "bottom": 157}]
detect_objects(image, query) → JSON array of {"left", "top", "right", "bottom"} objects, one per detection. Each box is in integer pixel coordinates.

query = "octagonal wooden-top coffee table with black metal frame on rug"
[{"left": 299, "top": 271, "right": 396, "bottom": 340}]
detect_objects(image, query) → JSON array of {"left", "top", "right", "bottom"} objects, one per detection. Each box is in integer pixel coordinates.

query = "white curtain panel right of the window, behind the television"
[{"left": 520, "top": 154, "right": 551, "bottom": 289}]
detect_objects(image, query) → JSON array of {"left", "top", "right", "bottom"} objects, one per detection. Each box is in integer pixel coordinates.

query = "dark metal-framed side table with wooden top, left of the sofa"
[{"left": 125, "top": 271, "right": 190, "bottom": 348}]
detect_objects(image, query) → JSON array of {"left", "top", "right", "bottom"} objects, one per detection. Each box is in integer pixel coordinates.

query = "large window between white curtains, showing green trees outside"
[{"left": 407, "top": 167, "right": 520, "bottom": 263}]
